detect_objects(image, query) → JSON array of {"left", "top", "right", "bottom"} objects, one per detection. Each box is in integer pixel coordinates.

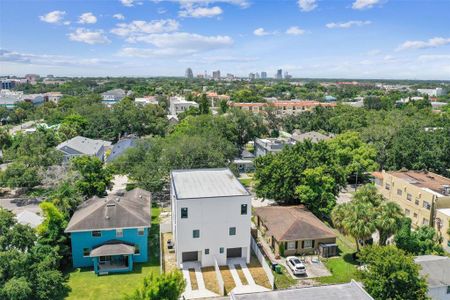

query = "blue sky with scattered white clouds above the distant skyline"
[{"left": 0, "top": 0, "right": 450, "bottom": 80}]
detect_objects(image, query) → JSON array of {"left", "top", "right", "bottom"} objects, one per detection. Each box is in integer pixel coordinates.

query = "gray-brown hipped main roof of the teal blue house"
[{"left": 65, "top": 188, "right": 151, "bottom": 232}]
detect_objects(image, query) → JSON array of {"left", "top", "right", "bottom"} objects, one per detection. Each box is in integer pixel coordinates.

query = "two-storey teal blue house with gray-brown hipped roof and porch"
[{"left": 65, "top": 188, "right": 151, "bottom": 275}]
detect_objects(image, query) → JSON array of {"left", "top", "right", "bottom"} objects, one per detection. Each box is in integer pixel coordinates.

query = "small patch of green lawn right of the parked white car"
[{"left": 317, "top": 234, "right": 359, "bottom": 284}]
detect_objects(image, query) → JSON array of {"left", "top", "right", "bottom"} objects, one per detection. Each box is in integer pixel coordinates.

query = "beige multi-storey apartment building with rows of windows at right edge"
[{"left": 373, "top": 171, "right": 450, "bottom": 251}]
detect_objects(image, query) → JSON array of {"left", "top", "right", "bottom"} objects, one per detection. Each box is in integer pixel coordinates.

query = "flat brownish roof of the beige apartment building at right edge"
[{"left": 387, "top": 170, "right": 450, "bottom": 197}]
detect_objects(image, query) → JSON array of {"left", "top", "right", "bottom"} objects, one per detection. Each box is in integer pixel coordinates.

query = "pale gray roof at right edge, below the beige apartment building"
[{"left": 414, "top": 255, "right": 450, "bottom": 287}]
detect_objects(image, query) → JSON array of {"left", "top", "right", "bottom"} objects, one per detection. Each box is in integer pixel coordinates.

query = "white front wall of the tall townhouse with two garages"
[{"left": 171, "top": 186, "right": 251, "bottom": 267}]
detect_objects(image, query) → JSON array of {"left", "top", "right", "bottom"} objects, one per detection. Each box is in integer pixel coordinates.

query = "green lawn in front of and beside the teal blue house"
[{"left": 67, "top": 208, "right": 160, "bottom": 299}]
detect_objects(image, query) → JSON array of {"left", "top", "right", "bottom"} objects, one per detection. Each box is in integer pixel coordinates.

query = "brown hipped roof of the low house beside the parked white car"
[{"left": 255, "top": 205, "right": 336, "bottom": 241}]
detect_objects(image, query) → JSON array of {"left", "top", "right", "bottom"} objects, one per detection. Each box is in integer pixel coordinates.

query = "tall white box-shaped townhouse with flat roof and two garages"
[{"left": 170, "top": 168, "right": 252, "bottom": 267}]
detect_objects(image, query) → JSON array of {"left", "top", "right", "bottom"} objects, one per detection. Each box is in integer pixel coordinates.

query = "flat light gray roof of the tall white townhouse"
[{"left": 171, "top": 168, "right": 249, "bottom": 199}]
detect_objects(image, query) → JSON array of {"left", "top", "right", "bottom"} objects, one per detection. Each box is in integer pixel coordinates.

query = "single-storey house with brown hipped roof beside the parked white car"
[{"left": 254, "top": 205, "right": 337, "bottom": 256}]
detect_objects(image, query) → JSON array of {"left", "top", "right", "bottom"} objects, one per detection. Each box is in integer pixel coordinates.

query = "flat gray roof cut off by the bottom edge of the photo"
[{"left": 231, "top": 281, "right": 373, "bottom": 300}]
